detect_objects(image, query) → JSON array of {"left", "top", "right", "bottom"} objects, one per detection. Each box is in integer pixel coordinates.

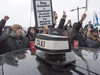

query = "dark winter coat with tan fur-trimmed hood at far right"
[{"left": 86, "top": 34, "right": 100, "bottom": 48}]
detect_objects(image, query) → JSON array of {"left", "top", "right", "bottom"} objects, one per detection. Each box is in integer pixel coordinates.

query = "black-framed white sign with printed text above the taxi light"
[{"left": 33, "top": 0, "right": 53, "bottom": 27}]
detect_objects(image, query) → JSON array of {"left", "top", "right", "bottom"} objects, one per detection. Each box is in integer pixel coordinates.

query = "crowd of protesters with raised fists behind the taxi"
[{"left": 0, "top": 12, "right": 100, "bottom": 54}]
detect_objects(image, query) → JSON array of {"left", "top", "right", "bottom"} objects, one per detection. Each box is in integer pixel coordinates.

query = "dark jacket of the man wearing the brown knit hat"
[{"left": 4, "top": 31, "right": 30, "bottom": 52}]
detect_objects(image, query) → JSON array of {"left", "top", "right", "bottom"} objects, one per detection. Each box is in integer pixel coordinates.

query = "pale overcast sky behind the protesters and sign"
[{"left": 0, "top": 0, "right": 100, "bottom": 27}]
